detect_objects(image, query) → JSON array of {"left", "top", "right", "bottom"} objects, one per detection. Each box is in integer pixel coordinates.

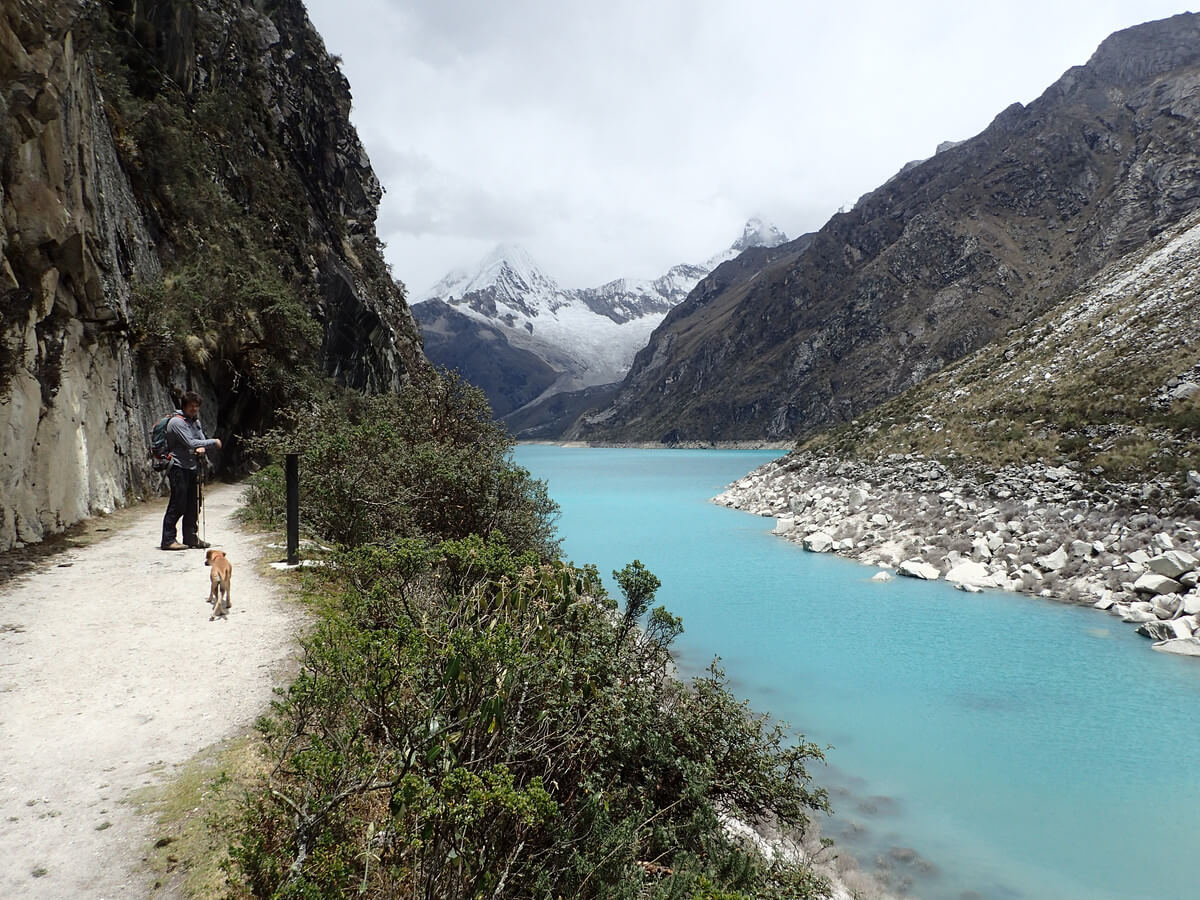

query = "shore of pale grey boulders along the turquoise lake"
[{"left": 714, "top": 452, "right": 1200, "bottom": 656}]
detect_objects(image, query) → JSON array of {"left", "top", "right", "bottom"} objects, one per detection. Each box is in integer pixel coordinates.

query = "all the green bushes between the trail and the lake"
[{"left": 230, "top": 369, "right": 828, "bottom": 898}]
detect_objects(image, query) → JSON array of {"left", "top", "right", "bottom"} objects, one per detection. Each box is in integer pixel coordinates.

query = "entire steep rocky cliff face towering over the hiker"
[{"left": 0, "top": 0, "right": 422, "bottom": 550}]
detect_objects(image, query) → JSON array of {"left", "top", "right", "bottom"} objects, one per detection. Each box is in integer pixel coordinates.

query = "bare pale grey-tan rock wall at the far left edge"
[{"left": 0, "top": 2, "right": 170, "bottom": 550}]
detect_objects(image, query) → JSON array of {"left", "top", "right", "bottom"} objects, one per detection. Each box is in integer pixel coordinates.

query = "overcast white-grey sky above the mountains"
[{"left": 305, "top": 0, "right": 1187, "bottom": 300}]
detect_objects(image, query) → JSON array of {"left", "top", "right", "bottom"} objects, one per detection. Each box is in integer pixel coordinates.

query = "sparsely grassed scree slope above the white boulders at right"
[{"left": 800, "top": 216, "right": 1200, "bottom": 505}]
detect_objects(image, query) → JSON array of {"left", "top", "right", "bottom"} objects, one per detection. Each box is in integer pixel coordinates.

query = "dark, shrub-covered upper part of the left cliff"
[{"left": 85, "top": 2, "right": 421, "bottom": 444}]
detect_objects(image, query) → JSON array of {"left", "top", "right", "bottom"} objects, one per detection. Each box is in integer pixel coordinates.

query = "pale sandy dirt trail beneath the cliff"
[{"left": 0, "top": 485, "right": 301, "bottom": 900}]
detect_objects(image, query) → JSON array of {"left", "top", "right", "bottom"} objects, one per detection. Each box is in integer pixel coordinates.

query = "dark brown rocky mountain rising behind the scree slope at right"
[{"left": 569, "top": 14, "right": 1200, "bottom": 442}]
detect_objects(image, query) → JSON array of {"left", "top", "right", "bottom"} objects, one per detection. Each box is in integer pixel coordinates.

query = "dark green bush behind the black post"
[{"left": 247, "top": 372, "right": 558, "bottom": 559}]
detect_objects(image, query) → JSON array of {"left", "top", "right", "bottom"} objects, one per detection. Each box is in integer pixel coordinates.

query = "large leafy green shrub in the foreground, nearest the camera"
[{"left": 233, "top": 535, "right": 827, "bottom": 898}]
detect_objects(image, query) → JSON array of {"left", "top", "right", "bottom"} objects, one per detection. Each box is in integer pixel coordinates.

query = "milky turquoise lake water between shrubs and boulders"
[{"left": 516, "top": 446, "right": 1200, "bottom": 900}]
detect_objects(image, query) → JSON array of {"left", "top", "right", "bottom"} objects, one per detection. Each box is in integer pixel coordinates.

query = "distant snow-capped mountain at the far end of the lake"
[{"left": 413, "top": 218, "right": 787, "bottom": 433}]
